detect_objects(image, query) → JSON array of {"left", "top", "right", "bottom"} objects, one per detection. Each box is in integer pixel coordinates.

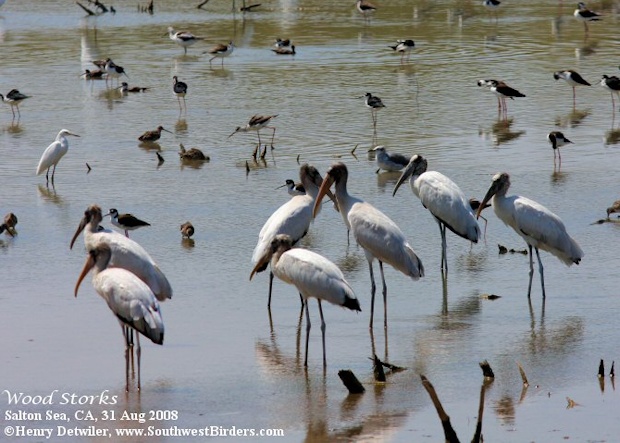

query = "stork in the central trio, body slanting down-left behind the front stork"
[{"left": 252, "top": 164, "right": 334, "bottom": 309}]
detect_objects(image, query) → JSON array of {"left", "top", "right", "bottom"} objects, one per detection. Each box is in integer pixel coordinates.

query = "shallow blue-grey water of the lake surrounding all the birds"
[{"left": 0, "top": 0, "right": 620, "bottom": 442}]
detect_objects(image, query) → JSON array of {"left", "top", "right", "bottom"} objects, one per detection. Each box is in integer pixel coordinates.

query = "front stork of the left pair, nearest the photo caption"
[{"left": 75, "top": 244, "right": 164, "bottom": 391}]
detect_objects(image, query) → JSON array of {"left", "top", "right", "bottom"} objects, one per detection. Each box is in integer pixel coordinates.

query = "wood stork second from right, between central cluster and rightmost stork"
[{"left": 392, "top": 155, "right": 480, "bottom": 272}]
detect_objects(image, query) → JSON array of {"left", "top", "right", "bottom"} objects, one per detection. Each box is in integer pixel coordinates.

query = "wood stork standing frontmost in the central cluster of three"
[{"left": 250, "top": 234, "right": 361, "bottom": 367}]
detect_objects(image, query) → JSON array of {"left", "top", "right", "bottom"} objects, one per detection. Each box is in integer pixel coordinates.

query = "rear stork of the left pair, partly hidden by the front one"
[{"left": 70, "top": 205, "right": 172, "bottom": 301}]
